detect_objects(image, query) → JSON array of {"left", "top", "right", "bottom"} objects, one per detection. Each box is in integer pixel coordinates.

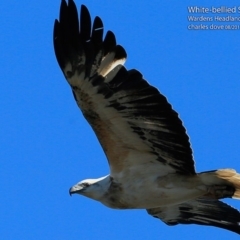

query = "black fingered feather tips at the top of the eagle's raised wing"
[{"left": 53, "top": 0, "right": 127, "bottom": 80}]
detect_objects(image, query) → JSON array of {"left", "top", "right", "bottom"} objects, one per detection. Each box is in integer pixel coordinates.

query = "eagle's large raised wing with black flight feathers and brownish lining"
[{"left": 54, "top": 0, "right": 195, "bottom": 175}]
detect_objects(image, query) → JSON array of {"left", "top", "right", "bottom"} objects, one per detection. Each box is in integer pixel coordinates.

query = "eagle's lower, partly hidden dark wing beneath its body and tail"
[{"left": 147, "top": 199, "right": 240, "bottom": 234}]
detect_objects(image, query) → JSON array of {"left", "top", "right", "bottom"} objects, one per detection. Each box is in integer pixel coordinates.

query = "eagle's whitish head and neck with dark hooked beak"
[{"left": 69, "top": 175, "right": 111, "bottom": 201}]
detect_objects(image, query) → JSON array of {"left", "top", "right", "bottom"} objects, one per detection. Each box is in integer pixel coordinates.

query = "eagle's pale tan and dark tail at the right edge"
[{"left": 199, "top": 169, "right": 240, "bottom": 199}]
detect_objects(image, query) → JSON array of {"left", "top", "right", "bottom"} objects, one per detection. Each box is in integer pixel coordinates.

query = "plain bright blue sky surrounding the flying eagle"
[{"left": 0, "top": 0, "right": 240, "bottom": 240}]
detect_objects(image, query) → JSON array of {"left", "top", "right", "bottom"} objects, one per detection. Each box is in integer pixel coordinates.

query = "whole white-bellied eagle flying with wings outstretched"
[{"left": 53, "top": 0, "right": 240, "bottom": 234}]
